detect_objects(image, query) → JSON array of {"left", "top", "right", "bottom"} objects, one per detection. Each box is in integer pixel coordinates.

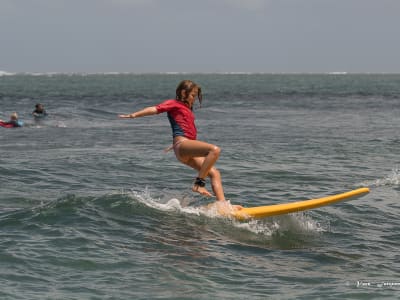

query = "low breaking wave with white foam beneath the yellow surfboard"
[{"left": 0, "top": 190, "right": 329, "bottom": 248}]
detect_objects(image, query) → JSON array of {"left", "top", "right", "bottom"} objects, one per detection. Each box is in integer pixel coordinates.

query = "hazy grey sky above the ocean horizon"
[{"left": 0, "top": 0, "right": 400, "bottom": 73}]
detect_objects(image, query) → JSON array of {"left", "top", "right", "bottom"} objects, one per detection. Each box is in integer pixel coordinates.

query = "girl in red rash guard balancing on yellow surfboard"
[{"left": 119, "top": 80, "right": 238, "bottom": 206}]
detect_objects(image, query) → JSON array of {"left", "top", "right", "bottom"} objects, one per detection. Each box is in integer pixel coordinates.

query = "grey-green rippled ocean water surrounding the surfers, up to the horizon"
[{"left": 0, "top": 73, "right": 400, "bottom": 300}]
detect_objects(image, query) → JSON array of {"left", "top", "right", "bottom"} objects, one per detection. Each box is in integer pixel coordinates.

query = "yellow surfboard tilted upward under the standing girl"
[{"left": 221, "top": 187, "right": 369, "bottom": 220}]
